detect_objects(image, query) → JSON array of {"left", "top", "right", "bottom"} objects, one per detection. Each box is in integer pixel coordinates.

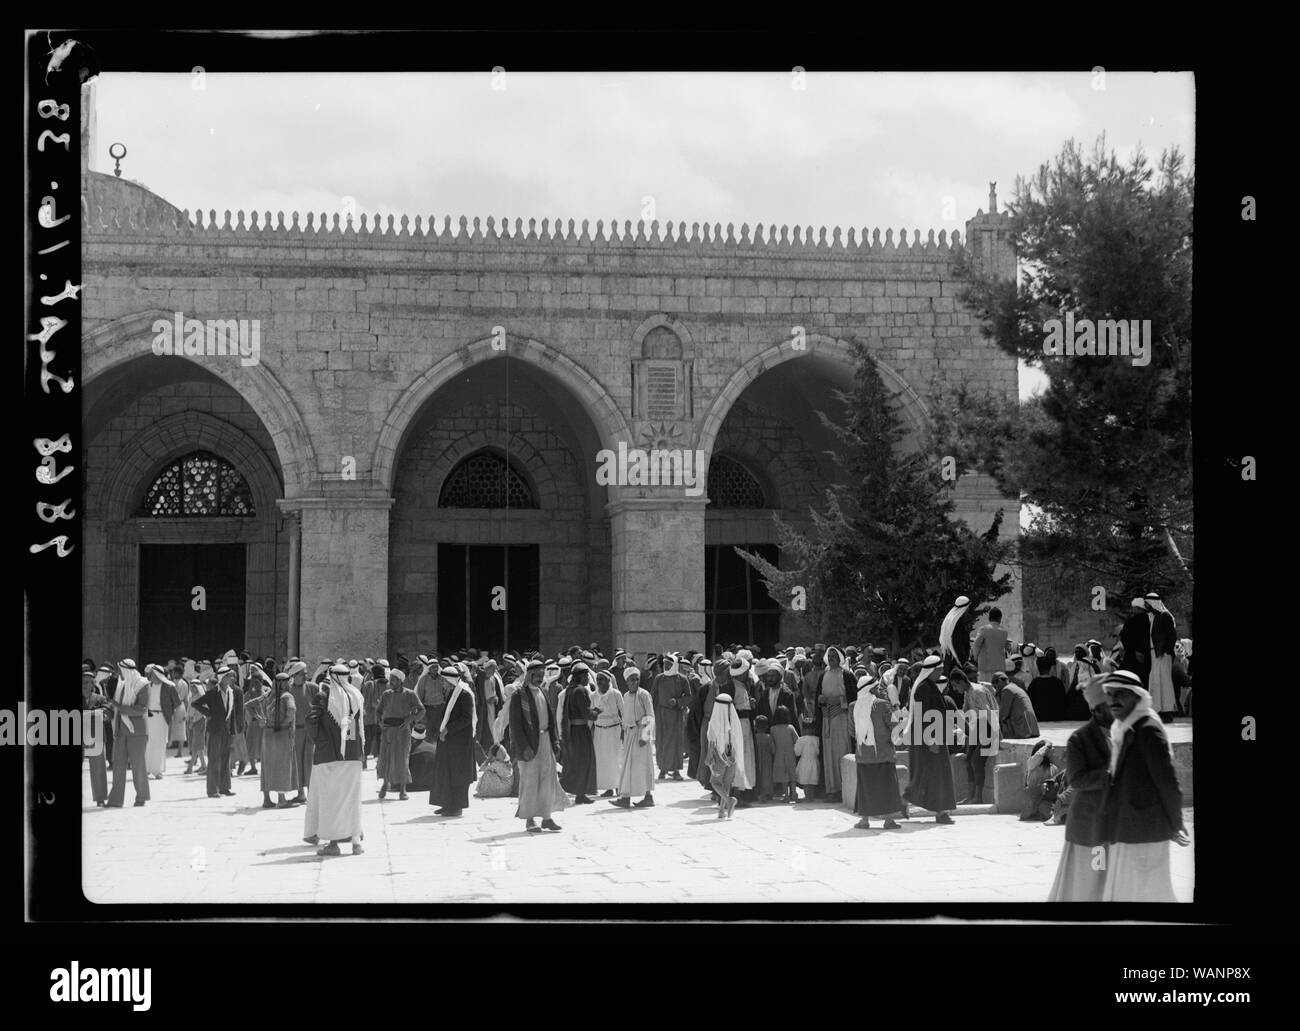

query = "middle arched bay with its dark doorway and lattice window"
[{"left": 389, "top": 351, "right": 611, "bottom": 655}]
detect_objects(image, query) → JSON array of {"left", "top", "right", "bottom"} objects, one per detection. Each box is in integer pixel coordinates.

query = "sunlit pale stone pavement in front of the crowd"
[{"left": 82, "top": 757, "right": 1195, "bottom": 905}]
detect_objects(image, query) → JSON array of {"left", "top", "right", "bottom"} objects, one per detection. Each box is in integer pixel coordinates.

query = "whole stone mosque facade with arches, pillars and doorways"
[{"left": 81, "top": 100, "right": 1022, "bottom": 660}]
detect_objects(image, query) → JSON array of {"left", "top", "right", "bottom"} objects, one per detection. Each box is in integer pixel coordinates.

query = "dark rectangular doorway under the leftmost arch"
[{"left": 135, "top": 545, "right": 247, "bottom": 670}]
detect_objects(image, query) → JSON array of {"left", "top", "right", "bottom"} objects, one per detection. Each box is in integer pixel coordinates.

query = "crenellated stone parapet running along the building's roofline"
[{"left": 85, "top": 202, "right": 963, "bottom": 260}]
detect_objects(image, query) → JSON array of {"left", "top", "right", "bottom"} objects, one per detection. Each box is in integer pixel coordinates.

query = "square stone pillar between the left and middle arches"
[{"left": 287, "top": 493, "right": 393, "bottom": 666}]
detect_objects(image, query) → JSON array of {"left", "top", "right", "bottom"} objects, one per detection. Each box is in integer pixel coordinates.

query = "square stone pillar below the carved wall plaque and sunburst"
[{"left": 606, "top": 497, "right": 706, "bottom": 654}]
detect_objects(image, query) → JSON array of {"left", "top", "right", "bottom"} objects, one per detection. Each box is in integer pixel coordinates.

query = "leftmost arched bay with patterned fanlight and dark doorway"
[{"left": 82, "top": 356, "right": 289, "bottom": 662}]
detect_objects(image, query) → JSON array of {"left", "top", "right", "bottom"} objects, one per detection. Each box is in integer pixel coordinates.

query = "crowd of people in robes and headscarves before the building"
[{"left": 82, "top": 595, "right": 1191, "bottom": 901}]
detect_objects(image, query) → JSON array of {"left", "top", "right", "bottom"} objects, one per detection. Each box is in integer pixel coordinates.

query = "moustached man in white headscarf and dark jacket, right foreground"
[{"left": 1102, "top": 670, "right": 1190, "bottom": 902}]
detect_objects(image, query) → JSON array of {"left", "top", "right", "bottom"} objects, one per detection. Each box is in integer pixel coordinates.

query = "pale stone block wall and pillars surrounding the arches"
[{"left": 83, "top": 183, "right": 1017, "bottom": 654}]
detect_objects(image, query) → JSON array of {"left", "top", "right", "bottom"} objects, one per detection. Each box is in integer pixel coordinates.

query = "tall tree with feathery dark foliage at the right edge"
[{"left": 936, "top": 137, "right": 1193, "bottom": 608}]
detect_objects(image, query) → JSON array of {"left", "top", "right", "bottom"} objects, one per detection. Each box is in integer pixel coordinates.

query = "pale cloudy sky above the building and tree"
[{"left": 92, "top": 70, "right": 1195, "bottom": 394}]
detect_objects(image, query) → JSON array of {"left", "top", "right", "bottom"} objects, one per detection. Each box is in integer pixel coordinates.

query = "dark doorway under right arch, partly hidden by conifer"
[{"left": 705, "top": 545, "right": 781, "bottom": 654}]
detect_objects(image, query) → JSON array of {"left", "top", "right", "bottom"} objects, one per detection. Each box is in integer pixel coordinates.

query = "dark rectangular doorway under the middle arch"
[{"left": 438, "top": 545, "right": 540, "bottom": 655}]
